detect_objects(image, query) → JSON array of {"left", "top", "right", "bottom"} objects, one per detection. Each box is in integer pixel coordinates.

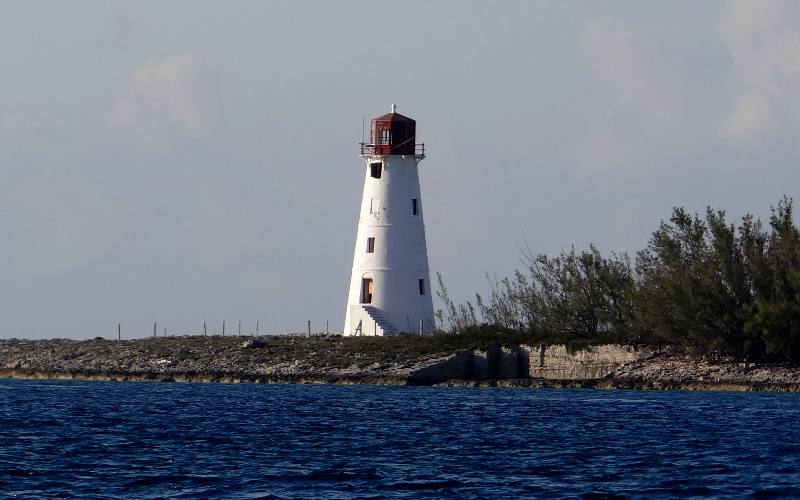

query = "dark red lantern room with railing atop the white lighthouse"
[{"left": 361, "top": 104, "right": 425, "bottom": 156}]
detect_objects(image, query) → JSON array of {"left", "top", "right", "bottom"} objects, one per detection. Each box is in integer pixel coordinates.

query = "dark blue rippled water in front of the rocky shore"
[{"left": 0, "top": 380, "right": 800, "bottom": 498}]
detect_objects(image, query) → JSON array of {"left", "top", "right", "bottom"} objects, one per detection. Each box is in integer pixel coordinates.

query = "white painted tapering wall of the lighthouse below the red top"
[{"left": 344, "top": 155, "right": 435, "bottom": 335}]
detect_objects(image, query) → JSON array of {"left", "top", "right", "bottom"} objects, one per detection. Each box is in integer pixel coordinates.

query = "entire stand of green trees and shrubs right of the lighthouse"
[{"left": 439, "top": 197, "right": 800, "bottom": 362}]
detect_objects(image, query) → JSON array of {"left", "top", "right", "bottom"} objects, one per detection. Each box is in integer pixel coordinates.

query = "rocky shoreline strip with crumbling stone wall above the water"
[{"left": 0, "top": 335, "right": 800, "bottom": 392}]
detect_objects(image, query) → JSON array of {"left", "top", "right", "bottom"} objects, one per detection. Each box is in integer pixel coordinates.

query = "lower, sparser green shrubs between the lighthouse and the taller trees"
[{"left": 438, "top": 246, "right": 640, "bottom": 341}]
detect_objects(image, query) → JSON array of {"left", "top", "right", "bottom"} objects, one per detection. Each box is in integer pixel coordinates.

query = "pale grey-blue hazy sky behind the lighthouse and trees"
[{"left": 0, "top": 0, "right": 800, "bottom": 339}]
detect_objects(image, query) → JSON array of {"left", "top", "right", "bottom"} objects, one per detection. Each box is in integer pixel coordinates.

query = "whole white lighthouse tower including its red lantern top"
[{"left": 344, "top": 104, "right": 435, "bottom": 335}]
